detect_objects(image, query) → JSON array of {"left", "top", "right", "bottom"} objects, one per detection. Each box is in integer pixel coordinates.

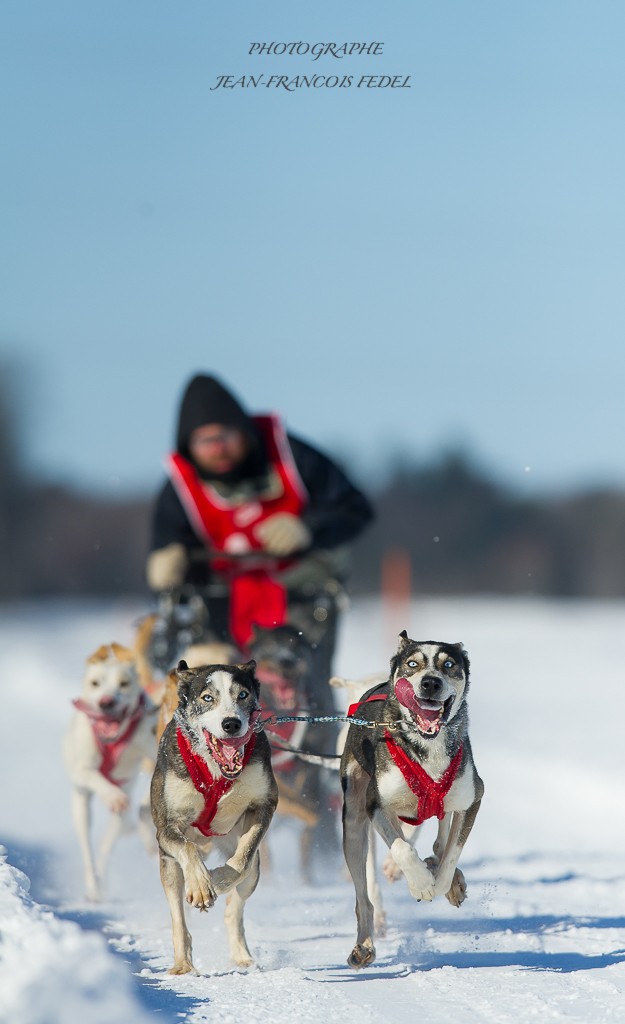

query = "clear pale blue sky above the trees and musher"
[{"left": 0, "top": 0, "right": 625, "bottom": 494}]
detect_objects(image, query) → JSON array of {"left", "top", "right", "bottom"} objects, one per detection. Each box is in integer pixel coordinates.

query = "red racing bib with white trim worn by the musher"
[{"left": 167, "top": 416, "right": 308, "bottom": 649}]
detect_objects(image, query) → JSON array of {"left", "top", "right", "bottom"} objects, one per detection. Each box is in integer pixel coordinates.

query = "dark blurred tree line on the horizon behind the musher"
[{"left": 0, "top": 368, "right": 625, "bottom": 600}]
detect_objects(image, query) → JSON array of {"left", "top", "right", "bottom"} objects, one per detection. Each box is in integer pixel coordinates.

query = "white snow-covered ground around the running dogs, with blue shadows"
[{"left": 0, "top": 599, "right": 625, "bottom": 1024}]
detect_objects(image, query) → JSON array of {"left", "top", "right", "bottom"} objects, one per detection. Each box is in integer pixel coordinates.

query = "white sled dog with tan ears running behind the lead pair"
[{"left": 64, "top": 643, "right": 157, "bottom": 900}]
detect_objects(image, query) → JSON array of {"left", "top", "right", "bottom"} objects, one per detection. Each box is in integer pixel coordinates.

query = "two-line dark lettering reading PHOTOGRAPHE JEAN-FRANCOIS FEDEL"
[{"left": 210, "top": 40, "right": 411, "bottom": 92}]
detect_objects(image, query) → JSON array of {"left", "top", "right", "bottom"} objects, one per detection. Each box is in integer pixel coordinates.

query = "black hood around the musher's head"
[{"left": 176, "top": 374, "right": 265, "bottom": 479}]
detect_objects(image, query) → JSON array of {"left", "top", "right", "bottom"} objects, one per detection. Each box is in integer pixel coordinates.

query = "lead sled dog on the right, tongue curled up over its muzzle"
[{"left": 341, "top": 631, "right": 484, "bottom": 969}]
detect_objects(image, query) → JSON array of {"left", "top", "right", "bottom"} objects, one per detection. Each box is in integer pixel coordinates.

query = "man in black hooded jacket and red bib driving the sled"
[{"left": 147, "top": 375, "right": 373, "bottom": 851}]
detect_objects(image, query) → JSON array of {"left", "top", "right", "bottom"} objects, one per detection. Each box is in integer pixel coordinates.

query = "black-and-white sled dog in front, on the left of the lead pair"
[{"left": 152, "top": 660, "right": 278, "bottom": 974}]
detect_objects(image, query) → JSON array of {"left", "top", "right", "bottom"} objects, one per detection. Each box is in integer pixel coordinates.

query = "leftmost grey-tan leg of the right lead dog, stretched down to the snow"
[{"left": 343, "top": 768, "right": 375, "bottom": 970}]
